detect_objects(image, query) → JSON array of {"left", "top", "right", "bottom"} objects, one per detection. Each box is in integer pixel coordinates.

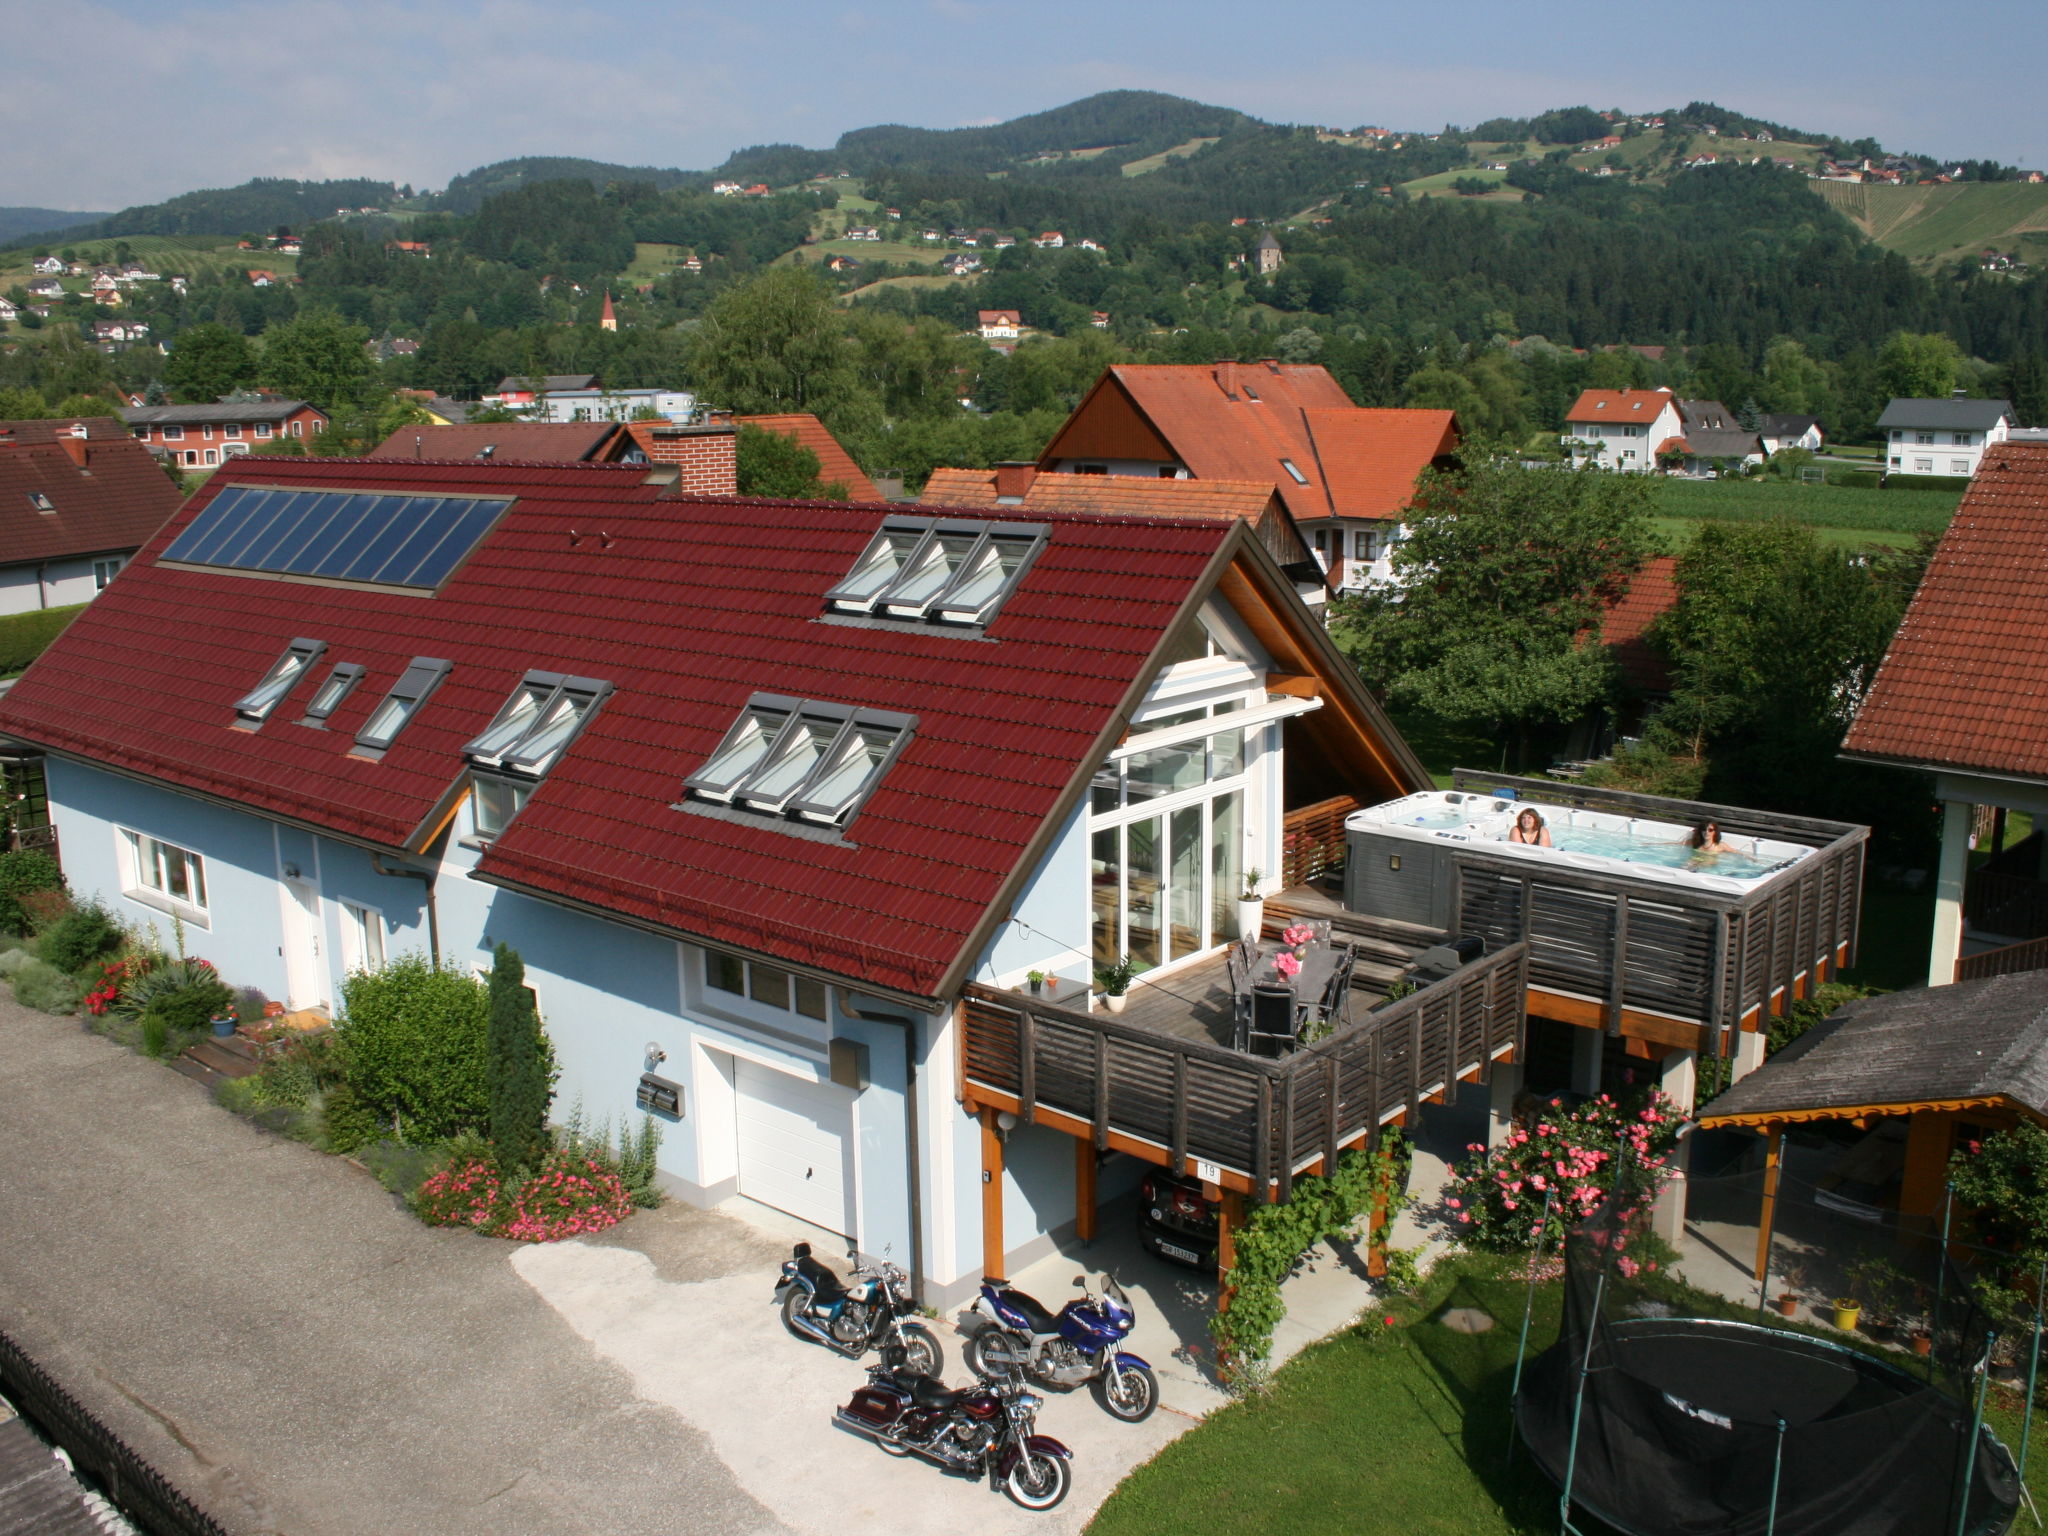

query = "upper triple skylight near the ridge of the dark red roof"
[{"left": 825, "top": 518, "right": 1047, "bottom": 625}]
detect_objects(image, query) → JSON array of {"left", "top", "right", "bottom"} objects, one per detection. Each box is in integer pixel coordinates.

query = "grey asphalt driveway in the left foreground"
[{"left": 0, "top": 991, "right": 782, "bottom": 1536}]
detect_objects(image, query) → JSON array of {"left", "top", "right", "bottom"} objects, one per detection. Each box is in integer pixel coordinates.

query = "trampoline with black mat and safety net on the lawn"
[{"left": 1516, "top": 1163, "right": 2021, "bottom": 1536}]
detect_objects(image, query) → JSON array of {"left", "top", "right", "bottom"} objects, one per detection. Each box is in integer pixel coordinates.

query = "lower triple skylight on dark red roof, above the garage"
[{"left": 684, "top": 694, "right": 915, "bottom": 827}]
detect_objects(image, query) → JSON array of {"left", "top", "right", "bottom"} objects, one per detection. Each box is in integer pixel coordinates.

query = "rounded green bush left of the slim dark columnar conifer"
[{"left": 336, "top": 954, "right": 492, "bottom": 1145}]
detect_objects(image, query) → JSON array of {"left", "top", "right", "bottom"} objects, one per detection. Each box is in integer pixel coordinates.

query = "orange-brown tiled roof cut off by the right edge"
[{"left": 1841, "top": 442, "right": 2048, "bottom": 778}]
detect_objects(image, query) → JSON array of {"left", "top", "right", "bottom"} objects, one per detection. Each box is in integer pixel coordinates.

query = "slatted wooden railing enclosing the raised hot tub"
[{"left": 1452, "top": 768, "right": 1870, "bottom": 1030}]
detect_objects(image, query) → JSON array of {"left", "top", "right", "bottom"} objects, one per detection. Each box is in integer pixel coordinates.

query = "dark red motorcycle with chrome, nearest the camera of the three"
[{"left": 834, "top": 1346, "right": 1073, "bottom": 1509}]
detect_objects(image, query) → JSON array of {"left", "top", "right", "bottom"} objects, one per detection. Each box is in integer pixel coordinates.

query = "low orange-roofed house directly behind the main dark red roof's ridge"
[{"left": 918, "top": 463, "right": 1329, "bottom": 608}]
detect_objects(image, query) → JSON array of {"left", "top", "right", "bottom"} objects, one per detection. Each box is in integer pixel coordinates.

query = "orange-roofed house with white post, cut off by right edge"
[{"left": 1841, "top": 440, "right": 2048, "bottom": 987}]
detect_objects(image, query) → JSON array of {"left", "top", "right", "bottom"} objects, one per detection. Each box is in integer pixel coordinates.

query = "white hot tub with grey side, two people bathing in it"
[{"left": 1343, "top": 791, "right": 1812, "bottom": 928}]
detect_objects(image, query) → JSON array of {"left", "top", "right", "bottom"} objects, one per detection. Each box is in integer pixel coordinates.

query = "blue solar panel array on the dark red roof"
[{"left": 162, "top": 485, "right": 512, "bottom": 590}]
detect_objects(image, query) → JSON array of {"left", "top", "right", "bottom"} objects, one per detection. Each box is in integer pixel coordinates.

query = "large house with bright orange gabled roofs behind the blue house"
[{"left": 1038, "top": 360, "right": 1462, "bottom": 592}]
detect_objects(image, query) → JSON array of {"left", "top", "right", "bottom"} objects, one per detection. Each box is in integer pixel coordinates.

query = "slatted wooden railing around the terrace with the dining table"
[{"left": 961, "top": 944, "right": 1528, "bottom": 1198}]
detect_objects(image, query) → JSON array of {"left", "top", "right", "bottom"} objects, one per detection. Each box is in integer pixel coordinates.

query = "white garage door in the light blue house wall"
[{"left": 733, "top": 1057, "right": 854, "bottom": 1235}]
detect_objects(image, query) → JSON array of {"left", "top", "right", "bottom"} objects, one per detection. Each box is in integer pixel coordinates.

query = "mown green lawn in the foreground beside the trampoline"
[{"left": 1087, "top": 1255, "right": 2048, "bottom": 1536}]
